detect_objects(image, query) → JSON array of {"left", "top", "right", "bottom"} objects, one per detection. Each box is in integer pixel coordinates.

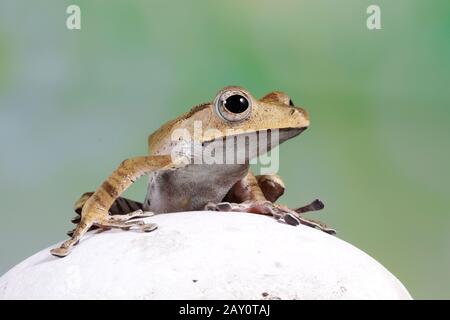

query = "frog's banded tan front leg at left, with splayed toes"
[{"left": 51, "top": 155, "right": 176, "bottom": 257}]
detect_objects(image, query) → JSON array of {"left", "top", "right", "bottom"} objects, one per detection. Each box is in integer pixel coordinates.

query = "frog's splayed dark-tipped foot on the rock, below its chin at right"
[{"left": 205, "top": 200, "right": 336, "bottom": 234}]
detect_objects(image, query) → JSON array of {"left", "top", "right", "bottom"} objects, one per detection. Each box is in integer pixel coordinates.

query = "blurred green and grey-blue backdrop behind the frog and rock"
[{"left": 0, "top": 0, "right": 450, "bottom": 299}]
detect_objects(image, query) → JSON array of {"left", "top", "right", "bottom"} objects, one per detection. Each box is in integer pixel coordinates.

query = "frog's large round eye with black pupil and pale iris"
[{"left": 215, "top": 90, "right": 252, "bottom": 121}]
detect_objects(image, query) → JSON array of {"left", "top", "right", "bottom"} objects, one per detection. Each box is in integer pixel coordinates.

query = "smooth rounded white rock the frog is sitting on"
[{"left": 0, "top": 211, "right": 411, "bottom": 299}]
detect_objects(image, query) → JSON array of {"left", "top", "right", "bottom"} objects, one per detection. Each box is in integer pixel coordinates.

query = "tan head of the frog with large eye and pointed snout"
[{"left": 149, "top": 86, "right": 309, "bottom": 157}]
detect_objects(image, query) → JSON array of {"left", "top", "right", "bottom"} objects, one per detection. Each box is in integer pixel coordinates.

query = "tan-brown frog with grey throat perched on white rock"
[{"left": 51, "top": 86, "right": 336, "bottom": 257}]
